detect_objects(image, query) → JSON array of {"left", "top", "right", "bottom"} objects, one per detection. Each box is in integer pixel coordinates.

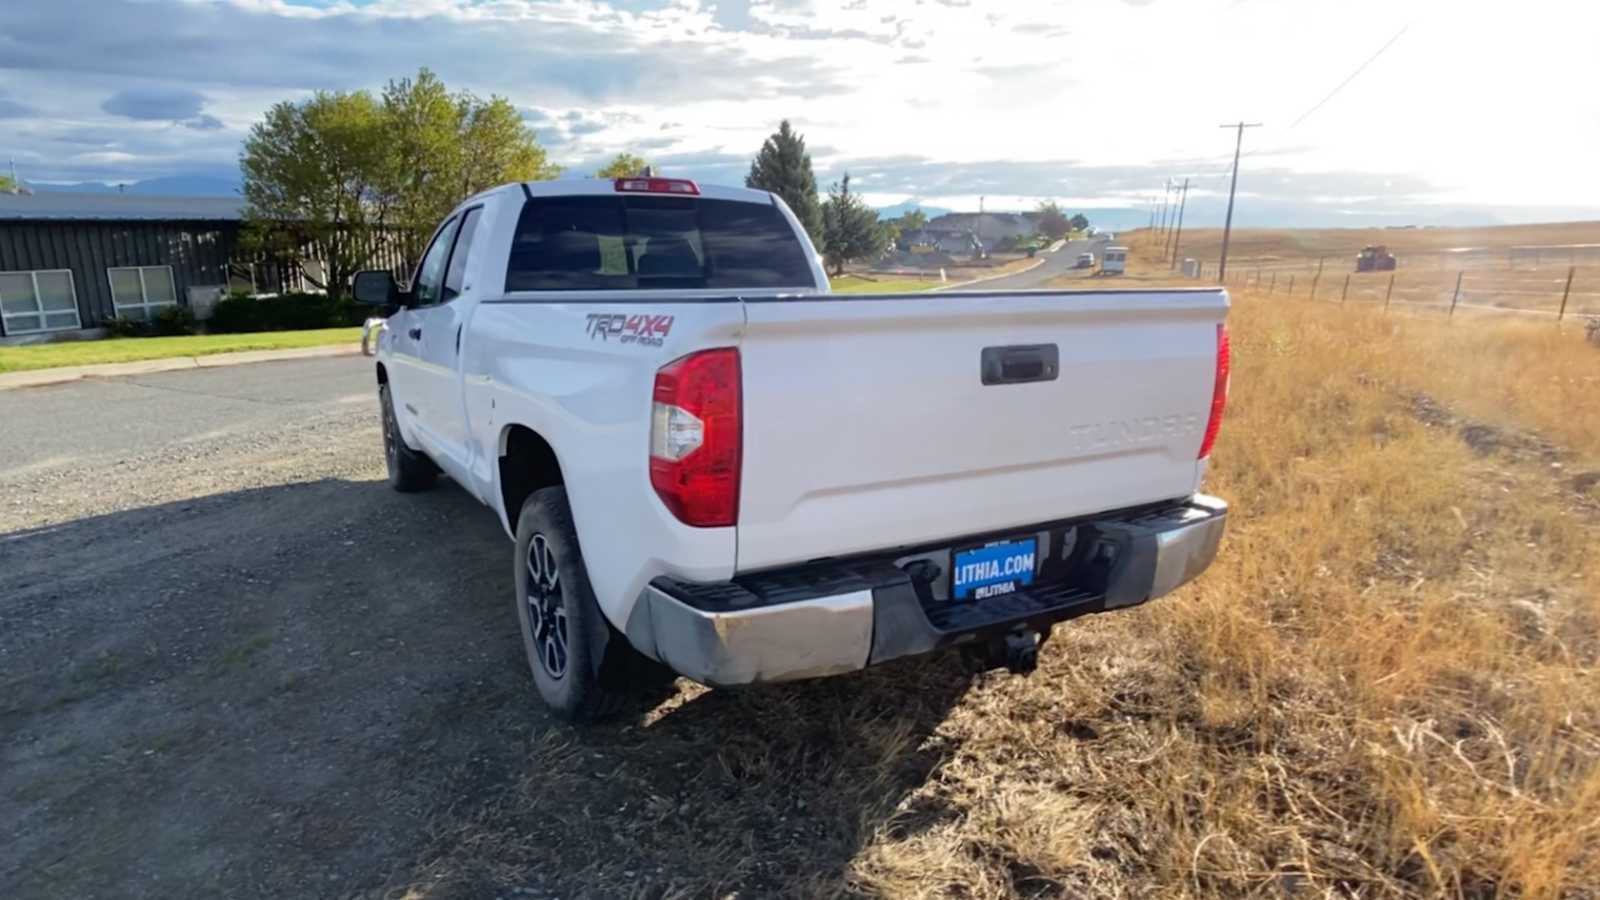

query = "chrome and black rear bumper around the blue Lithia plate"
[{"left": 626, "top": 495, "right": 1227, "bottom": 685}]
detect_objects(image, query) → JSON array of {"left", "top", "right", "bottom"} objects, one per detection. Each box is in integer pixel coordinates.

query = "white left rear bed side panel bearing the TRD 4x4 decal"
[{"left": 462, "top": 301, "right": 742, "bottom": 634}]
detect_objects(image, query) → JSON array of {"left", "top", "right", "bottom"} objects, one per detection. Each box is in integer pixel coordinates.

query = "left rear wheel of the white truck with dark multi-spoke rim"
[{"left": 512, "top": 485, "right": 672, "bottom": 722}]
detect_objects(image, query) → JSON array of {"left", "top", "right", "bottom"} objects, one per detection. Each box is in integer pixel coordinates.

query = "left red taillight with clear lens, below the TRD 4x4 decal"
[{"left": 650, "top": 348, "right": 742, "bottom": 528}]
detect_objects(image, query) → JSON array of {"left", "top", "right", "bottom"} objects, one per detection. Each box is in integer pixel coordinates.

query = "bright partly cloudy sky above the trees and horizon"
[{"left": 0, "top": 0, "right": 1600, "bottom": 224}]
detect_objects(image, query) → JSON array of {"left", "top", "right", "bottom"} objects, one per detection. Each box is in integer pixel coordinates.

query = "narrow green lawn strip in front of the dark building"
[{"left": 0, "top": 327, "right": 362, "bottom": 372}]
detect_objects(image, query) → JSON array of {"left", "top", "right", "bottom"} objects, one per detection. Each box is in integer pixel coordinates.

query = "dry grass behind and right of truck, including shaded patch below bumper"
[{"left": 403, "top": 254, "right": 1600, "bottom": 898}]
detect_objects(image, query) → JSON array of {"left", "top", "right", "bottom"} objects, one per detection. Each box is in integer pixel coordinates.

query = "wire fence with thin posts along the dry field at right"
[{"left": 1198, "top": 257, "right": 1600, "bottom": 322}]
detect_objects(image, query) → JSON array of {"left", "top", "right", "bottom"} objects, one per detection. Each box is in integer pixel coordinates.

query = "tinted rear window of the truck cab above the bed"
[{"left": 506, "top": 195, "right": 814, "bottom": 291}]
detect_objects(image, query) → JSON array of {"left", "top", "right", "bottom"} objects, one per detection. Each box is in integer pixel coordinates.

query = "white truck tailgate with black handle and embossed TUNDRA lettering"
[{"left": 738, "top": 288, "right": 1229, "bottom": 570}]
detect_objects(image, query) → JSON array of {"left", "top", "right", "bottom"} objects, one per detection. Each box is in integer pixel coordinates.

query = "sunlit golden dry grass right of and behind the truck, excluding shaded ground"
[{"left": 854, "top": 264, "right": 1600, "bottom": 897}]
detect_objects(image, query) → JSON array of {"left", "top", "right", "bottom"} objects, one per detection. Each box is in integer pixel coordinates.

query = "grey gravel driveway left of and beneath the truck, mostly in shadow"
[{"left": 0, "top": 359, "right": 971, "bottom": 898}]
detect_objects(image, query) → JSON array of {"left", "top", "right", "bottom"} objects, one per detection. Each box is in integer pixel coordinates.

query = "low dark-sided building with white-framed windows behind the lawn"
[{"left": 0, "top": 192, "right": 402, "bottom": 338}]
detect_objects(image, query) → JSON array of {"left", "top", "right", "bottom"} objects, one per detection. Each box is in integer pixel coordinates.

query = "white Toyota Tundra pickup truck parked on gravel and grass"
[{"left": 354, "top": 176, "right": 1229, "bottom": 719}]
